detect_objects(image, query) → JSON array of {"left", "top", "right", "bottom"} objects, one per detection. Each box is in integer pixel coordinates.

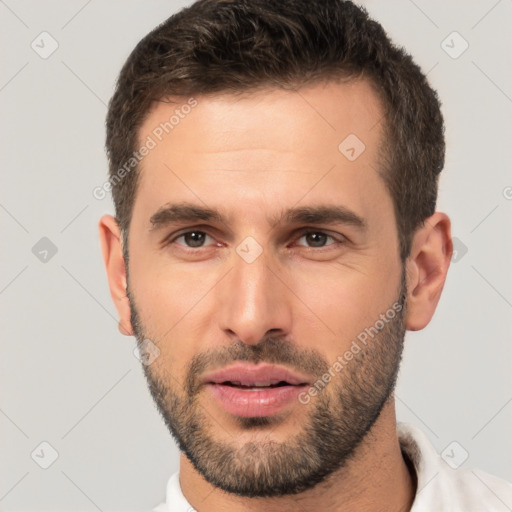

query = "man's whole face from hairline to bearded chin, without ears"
[{"left": 128, "top": 81, "right": 406, "bottom": 496}]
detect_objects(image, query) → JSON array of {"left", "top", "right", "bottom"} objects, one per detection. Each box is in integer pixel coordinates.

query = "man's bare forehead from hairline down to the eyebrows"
[{"left": 133, "top": 80, "right": 383, "bottom": 230}]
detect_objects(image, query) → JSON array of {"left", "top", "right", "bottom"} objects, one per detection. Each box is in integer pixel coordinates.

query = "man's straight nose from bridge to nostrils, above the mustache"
[{"left": 218, "top": 247, "right": 292, "bottom": 345}]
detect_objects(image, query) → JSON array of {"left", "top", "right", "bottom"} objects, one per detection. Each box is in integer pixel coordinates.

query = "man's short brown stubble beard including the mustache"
[{"left": 128, "top": 276, "right": 406, "bottom": 497}]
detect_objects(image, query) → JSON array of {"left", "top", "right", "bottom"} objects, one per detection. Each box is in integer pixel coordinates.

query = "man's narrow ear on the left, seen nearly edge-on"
[{"left": 98, "top": 215, "right": 133, "bottom": 336}]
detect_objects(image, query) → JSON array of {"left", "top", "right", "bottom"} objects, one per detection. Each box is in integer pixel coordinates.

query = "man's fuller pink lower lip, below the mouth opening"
[{"left": 206, "top": 383, "right": 306, "bottom": 418}]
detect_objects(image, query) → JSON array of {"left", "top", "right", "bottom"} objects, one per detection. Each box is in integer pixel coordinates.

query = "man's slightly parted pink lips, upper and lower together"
[{"left": 203, "top": 364, "right": 310, "bottom": 417}]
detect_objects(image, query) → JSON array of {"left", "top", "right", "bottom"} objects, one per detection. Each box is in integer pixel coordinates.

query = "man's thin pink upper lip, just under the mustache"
[{"left": 202, "top": 363, "right": 309, "bottom": 386}]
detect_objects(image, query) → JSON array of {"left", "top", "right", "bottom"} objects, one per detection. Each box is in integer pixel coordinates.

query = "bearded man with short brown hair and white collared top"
[{"left": 100, "top": 0, "right": 512, "bottom": 512}]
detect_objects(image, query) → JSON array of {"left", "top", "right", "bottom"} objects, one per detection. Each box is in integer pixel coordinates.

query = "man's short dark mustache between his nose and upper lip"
[{"left": 185, "top": 336, "right": 329, "bottom": 398}]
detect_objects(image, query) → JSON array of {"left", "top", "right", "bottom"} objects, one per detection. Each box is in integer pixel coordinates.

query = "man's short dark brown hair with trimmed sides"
[{"left": 106, "top": 0, "right": 445, "bottom": 261}]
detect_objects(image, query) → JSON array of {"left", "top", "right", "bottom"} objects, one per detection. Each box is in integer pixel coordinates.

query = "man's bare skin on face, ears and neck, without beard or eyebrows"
[{"left": 99, "top": 81, "right": 452, "bottom": 512}]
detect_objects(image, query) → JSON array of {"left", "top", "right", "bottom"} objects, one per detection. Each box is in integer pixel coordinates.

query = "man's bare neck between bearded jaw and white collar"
[{"left": 180, "top": 395, "right": 416, "bottom": 512}]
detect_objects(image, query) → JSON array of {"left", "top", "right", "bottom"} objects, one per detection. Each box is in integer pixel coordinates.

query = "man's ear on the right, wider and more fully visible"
[{"left": 405, "top": 212, "right": 453, "bottom": 331}]
